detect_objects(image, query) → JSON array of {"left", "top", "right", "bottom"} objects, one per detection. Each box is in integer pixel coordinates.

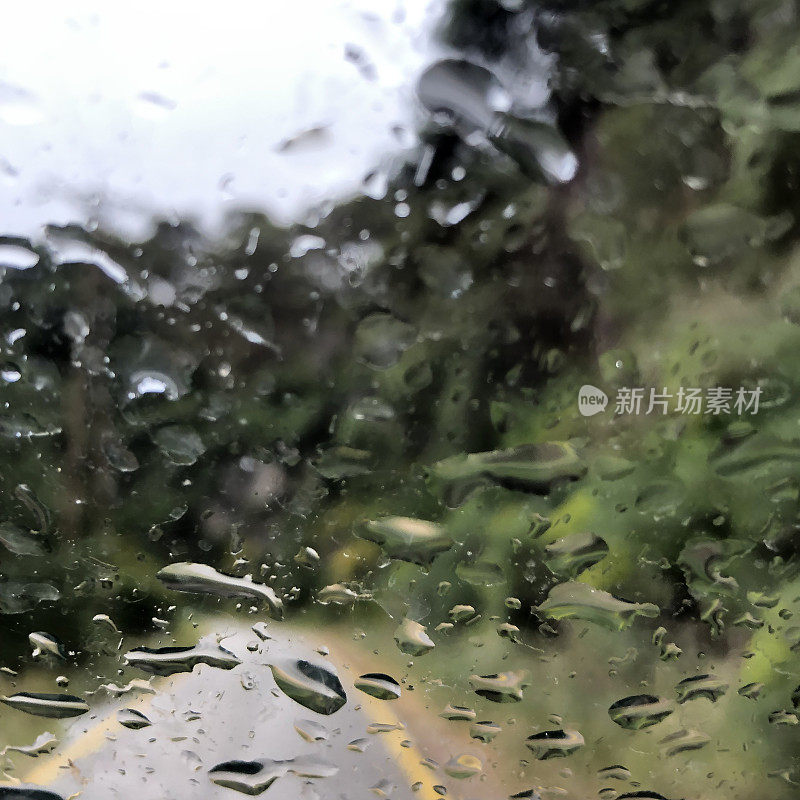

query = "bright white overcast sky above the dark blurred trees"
[{"left": 0, "top": 0, "right": 444, "bottom": 239}]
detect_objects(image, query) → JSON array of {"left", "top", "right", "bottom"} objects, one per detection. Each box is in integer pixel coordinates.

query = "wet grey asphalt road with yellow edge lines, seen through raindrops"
[{"left": 3, "top": 624, "right": 466, "bottom": 800}]
